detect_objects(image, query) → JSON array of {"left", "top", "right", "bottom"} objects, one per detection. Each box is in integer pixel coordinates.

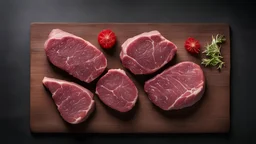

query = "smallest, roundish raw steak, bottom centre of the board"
[{"left": 96, "top": 69, "right": 138, "bottom": 112}]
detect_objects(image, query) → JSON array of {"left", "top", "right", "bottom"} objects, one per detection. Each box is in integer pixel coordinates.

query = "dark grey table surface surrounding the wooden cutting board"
[{"left": 0, "top": 0, "right": 256, "bottom": 144}]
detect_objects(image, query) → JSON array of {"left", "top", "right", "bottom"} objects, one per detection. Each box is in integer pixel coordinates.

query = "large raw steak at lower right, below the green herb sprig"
[{"left": 144, "top": 61, "right": 205, "bottom": 110}]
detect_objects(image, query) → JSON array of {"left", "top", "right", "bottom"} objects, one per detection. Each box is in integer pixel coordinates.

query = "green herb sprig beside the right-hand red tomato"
[{"left": 201, "top": 34, "right": 226, "bottom": 69}]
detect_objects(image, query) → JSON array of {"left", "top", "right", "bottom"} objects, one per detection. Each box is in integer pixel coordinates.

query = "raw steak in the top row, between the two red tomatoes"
[{"left": 120, "top": 30, "right": 177, "bottom": 75}]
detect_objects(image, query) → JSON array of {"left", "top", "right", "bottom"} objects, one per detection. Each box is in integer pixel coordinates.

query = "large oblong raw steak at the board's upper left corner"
[{"left": 44, "top": 29, "right": 107, "bottom": 83}]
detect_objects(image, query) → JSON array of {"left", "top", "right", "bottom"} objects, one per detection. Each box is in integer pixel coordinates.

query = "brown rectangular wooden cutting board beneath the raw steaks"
[{"left": 30, "top": 23, "right": 230, "bottom": 133}]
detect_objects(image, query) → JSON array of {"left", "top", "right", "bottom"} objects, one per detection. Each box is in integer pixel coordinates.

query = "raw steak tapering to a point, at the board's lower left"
[{"left": 43, "top": 77, "right": 95, "bottom": 124}]
